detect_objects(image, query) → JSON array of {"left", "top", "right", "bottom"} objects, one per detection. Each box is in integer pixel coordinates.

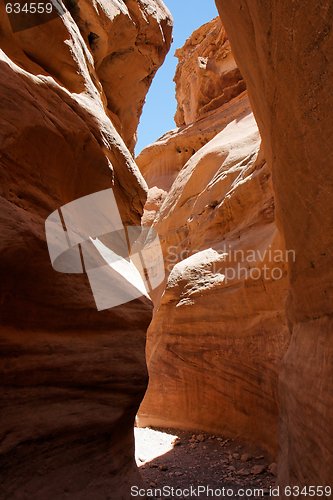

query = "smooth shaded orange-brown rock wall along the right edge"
[{"left": 217, "top": 0, "right": 333, "bottom": 486}]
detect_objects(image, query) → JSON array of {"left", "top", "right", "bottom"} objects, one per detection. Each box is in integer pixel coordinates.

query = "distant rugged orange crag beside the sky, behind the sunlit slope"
[{"left": 137, "top": 17, "right": 248, "bottom": 224}]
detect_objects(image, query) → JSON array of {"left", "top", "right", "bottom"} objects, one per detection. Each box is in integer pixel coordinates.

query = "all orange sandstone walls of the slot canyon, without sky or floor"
[{"left": 0, "top": 0, "right": 333, "bottom": 500}]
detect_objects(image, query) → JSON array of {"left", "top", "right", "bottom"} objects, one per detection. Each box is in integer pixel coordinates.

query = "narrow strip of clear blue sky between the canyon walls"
[{"left": 135, "top": 0, "right": 217, "bottom": 154}]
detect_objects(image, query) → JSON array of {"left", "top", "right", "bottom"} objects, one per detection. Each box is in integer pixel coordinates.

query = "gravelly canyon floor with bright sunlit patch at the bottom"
[{"left": 133, "top": 428, "right": 276, "bottom": 500}]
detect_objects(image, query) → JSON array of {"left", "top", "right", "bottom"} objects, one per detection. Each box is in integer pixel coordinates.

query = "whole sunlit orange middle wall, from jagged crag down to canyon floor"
[{"left": 139, "top": 19, "right": 289, "bottom": 454}]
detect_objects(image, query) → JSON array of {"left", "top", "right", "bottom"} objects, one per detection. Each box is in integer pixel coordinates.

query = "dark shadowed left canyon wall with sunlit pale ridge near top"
[{"left": 0, "top": 0, "right": 172, "bottom": 500}]
